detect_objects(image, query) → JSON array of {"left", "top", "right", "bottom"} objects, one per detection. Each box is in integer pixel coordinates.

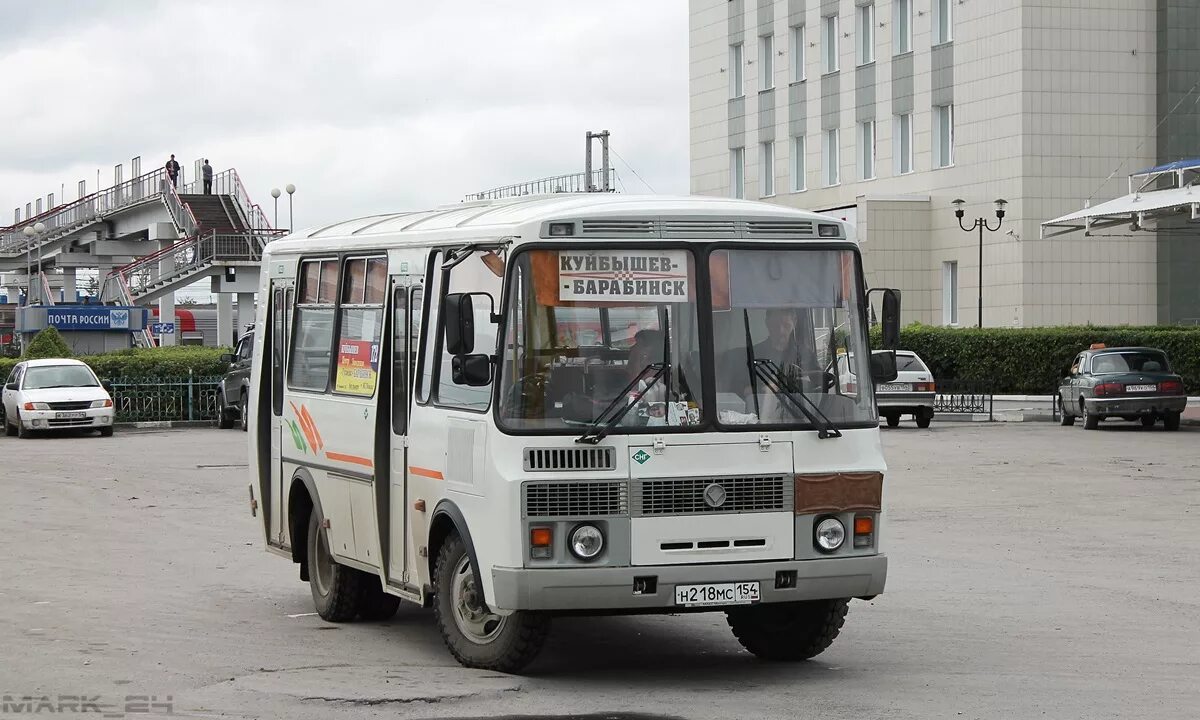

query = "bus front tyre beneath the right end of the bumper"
[{"left": 725, "top": 599, "right": 850, "bottom": 661}]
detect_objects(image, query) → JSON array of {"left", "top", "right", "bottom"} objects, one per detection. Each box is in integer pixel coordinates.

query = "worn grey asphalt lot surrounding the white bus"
[{"left": 0, "top": 420, "right": 1200, "bottom": 720}]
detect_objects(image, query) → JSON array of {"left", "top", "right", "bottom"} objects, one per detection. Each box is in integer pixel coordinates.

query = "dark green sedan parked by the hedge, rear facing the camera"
[{"left": 1057, "top": 344, "right": 1188, "bottom": 430}]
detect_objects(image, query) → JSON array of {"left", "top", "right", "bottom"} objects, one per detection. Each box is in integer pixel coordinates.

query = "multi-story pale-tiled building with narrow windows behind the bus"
[{"left": 690, "top": 0, "right": 1200, "bottom": 326}]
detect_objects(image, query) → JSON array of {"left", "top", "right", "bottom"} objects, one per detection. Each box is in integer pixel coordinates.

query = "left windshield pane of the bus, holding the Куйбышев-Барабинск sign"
[{"left": 499, "top": 247, "right": 702, "bottom": 432}]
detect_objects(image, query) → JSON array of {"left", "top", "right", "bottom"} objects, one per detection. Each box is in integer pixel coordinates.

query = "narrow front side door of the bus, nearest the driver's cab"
[{"left": 377, "top": 277, "right": 421, "bottom": 594}]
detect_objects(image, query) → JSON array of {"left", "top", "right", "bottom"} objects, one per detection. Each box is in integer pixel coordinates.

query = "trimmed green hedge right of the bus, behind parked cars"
[{"left": 871, "top": 324, "right": 1200, "bottom": 395}]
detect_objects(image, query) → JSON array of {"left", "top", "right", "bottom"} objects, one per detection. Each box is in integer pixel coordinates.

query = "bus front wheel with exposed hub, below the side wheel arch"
[{"left": 433, "top": 533, "right": 550, "bottom": 672}]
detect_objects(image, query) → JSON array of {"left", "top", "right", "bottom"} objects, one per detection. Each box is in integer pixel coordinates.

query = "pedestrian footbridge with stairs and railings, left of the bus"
[{"left": 0, "top": 168, "right": 283, "bottom": 344}]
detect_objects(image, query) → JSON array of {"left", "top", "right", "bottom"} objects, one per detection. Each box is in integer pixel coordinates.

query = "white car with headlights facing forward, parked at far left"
[{"left": 4, "top": 359, "right": 115, "bottom": 438}]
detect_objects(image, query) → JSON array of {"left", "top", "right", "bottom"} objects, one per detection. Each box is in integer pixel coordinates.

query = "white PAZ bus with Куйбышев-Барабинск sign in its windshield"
[{"left": 248, "top": 194, "right": 899, "bottom": 672}]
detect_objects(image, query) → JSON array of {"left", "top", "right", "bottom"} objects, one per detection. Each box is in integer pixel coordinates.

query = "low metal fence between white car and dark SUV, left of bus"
[{"left": 109, "top": 376, "right": 221, "bottom": 422}]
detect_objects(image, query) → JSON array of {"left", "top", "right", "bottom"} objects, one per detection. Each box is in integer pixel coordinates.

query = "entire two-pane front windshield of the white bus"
[{"left": 498, "top": 247, "right": 876, "bottom": 433}]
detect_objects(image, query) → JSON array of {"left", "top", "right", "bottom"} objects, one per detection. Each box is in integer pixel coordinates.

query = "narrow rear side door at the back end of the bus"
[{"left": 267, "top": 280, "right": 295, "bottom": 548}]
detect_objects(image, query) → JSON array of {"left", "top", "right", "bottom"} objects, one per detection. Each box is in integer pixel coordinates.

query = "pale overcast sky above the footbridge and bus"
[{"left": 0, "top": 0, "right": 688, "bottom": 227}]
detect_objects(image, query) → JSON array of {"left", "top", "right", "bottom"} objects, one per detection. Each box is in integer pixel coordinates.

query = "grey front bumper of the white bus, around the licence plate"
[{"left": 492, "top": 554, "right": 888, "bottom": 612}]
